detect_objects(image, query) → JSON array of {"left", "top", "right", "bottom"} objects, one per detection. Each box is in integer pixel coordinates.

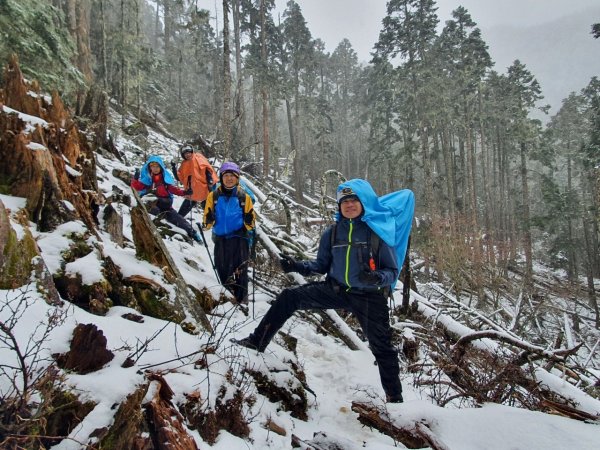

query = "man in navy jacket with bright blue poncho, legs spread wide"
[{"left": 234, "top": 179, "right": 414, "bottom": 403}]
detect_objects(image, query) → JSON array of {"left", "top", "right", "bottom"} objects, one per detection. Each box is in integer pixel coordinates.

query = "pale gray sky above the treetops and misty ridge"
[{"left": 268, "top": 0, "right": 600, "bottom": 62}]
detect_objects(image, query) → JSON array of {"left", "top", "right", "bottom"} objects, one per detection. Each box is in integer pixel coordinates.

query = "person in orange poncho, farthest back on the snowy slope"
[{"left": 173, "top": 145, "right": 219, "bottom": 217}]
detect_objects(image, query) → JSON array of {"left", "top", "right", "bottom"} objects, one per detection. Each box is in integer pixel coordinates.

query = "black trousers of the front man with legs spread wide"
[{"left": 250, "top": 281, "right": 402, "bottom": 397}]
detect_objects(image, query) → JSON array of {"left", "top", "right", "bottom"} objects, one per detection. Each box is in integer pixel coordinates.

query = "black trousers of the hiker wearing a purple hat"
[{"left": 213, "top": 234, "right": 250, "bottom": 303}]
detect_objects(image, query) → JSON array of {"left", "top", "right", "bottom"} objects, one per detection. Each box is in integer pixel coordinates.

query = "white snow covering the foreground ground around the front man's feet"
[{"left": 0, "top": 185, "right": 600, "bottom": 450}]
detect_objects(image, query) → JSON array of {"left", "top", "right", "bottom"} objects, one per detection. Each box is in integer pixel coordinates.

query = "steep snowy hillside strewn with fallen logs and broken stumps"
[{"left": 0, "top": 59, "right": 600, "bottom": 450}]
